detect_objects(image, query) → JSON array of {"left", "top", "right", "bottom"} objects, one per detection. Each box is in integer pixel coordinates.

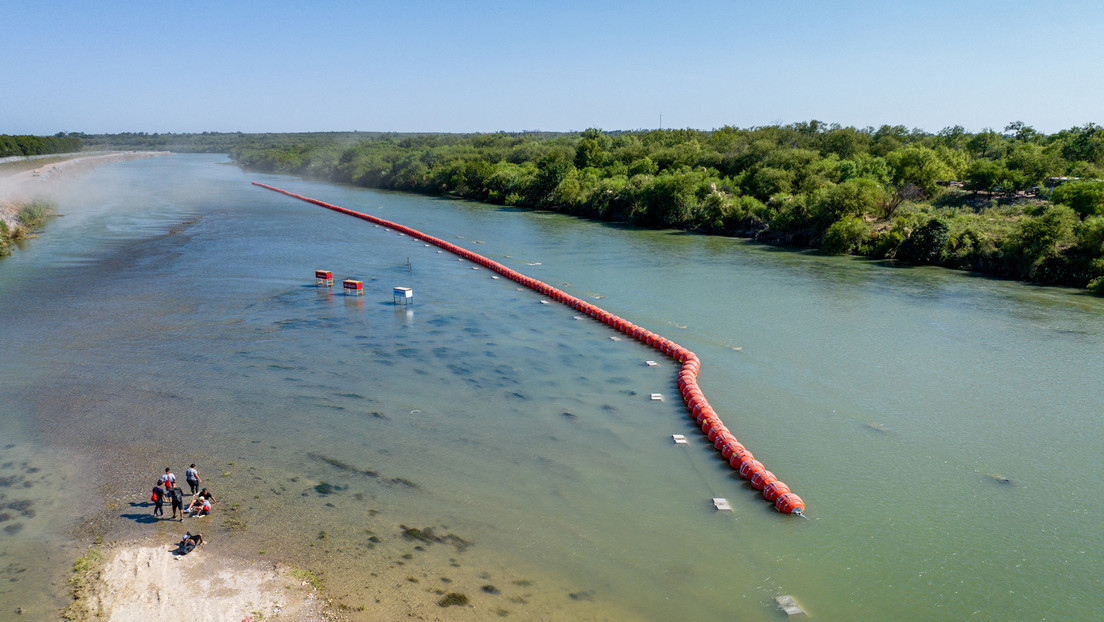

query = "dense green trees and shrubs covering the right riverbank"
[{"left": 231, "top": 120, "right": 1104, "bottom": 288}]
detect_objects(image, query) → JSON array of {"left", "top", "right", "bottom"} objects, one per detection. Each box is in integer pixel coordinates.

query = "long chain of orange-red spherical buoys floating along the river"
[{"left": 253, "top": 181, "right": 805, "bottom": 516}]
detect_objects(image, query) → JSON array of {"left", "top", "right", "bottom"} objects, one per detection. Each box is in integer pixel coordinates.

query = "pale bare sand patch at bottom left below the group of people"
[{"left": 68, "top": 534, "right": 330, "bottom": 622}]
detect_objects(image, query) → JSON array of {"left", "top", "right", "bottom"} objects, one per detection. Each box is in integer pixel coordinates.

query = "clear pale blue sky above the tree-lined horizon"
[{"left": 0, "top": 0, "right": 1104, "bottom": 135}]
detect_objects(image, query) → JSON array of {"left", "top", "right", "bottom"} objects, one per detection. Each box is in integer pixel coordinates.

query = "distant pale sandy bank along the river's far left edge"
[{"left": 0, "top": 151, "right": 169, "bottom": 225}]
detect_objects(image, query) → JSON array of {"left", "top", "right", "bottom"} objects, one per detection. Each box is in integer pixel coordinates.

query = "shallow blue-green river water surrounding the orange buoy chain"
[{"left": 0, "top": 155, "right": 1104, "bottom": 621}]
